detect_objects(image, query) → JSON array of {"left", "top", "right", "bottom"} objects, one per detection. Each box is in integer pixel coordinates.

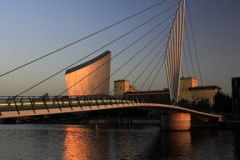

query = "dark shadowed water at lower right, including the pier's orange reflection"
[{"left": 138, "top": 128, "right": 240, "bottom": 159}]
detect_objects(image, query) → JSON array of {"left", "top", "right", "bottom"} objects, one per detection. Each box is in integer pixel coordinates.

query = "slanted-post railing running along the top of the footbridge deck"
[{"left": 0, "top": 95, "right": 223, "bottom": 115}]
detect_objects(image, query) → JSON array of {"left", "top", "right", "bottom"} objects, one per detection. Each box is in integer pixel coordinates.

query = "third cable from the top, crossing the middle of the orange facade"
[{"left": 58, "top": 22, "right": 172, "bottom": 96}]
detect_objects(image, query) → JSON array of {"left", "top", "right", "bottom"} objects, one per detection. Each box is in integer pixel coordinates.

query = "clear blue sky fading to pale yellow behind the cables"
[{"left": 0, "top": 0, "right": 240, "bottom": 96}]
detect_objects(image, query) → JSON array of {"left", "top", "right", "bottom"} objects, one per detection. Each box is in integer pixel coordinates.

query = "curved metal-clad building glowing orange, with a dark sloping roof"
[{"left": 65, "top": 51, "right": 111, "bottom": 96}]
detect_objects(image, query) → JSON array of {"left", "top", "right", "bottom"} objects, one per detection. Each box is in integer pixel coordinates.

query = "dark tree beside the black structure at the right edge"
[{"left": 213, "top": 92, "right": 232, "bottom": 114}]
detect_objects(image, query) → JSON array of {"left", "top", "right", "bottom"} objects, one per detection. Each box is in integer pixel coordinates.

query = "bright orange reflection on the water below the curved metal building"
[{"left": 63, "top": 126, "right": 107, "bottom": 160}]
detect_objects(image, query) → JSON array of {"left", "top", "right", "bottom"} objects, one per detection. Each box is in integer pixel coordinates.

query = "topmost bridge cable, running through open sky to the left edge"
[{"left": 0, "top": 0, "right": 169, "bottom": 77}]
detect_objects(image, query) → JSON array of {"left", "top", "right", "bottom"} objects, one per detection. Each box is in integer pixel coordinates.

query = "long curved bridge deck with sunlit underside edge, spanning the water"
[{"left": 0, "top": 99, "right": 224, "bottom": 120}]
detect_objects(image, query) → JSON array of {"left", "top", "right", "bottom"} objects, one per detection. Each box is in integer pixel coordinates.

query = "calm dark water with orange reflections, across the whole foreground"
[{"left": 0, "top": 124, "right": 240, "bottom": 160}]
